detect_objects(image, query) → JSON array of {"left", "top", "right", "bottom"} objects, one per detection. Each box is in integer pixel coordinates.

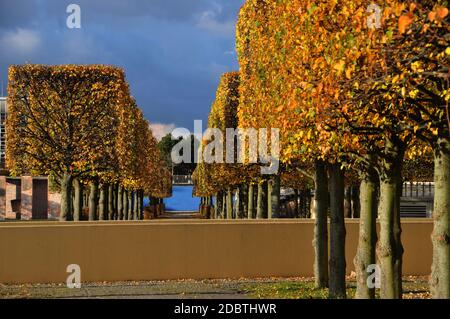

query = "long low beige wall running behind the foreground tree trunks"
[{"left": 0, "top": 220, "right": 432, "bottom": 283}]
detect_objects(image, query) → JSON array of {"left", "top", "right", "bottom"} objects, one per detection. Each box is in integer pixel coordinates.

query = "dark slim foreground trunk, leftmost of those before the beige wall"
[{"left": 313, "top": 161, "right": 328, "bottom": 288}]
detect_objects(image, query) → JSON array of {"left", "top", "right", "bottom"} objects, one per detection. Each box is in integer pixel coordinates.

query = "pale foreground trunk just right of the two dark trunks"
[{"left": 353, "top": 171, "right": 378, "bottom": 299}]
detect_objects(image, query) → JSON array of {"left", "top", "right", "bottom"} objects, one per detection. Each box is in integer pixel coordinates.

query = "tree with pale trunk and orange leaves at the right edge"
[{"left": 369, "top": 0, "right": 450, "bottom": 298}]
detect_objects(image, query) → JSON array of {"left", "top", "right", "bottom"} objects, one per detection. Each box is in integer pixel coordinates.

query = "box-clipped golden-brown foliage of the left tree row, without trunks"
[{"left": 7, "top": 64, "right": 170, "bottom": 196}]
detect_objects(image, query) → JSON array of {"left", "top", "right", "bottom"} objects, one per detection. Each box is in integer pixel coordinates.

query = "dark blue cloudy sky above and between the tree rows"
[{"left": 0, "top": 0, "right": 244, "bottom": 139}]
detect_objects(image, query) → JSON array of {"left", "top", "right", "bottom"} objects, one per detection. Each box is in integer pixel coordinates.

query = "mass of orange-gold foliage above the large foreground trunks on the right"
[{"left": 237, "top": 0, "right": 450, "bottom": 176}]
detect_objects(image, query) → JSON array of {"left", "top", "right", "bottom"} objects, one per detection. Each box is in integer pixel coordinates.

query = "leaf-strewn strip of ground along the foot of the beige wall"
[{"left": 0, "top": 277, "right": 430, "bottom": 299}]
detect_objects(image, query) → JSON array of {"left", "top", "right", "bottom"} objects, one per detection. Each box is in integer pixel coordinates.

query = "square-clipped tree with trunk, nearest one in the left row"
[{"left": 7, "top": 65, "right": 125, "bottom": 220}]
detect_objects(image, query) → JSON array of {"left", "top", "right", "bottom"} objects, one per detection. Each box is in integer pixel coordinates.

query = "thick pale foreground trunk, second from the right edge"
[{"left": 377, "top": 141, "right": 404, "bottom": 299}]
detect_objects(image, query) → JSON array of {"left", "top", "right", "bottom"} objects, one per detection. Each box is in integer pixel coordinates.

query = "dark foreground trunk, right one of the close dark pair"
[{"left": 328, "top": 163, "right": 347, "bottom": 299}]
